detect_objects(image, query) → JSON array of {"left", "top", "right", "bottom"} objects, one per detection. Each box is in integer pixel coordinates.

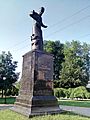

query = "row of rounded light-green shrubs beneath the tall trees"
[{"left": 54, "top": 86, "right": 90, "bottom": 99}]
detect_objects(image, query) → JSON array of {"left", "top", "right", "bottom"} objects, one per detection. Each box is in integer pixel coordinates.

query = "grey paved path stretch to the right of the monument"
[{"left": 60, "top": 105, "right": 90, "bottom": 117}]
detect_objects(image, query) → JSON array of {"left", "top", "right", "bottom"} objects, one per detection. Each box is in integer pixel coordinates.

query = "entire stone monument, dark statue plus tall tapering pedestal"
[{"left": 12, "top": 7, "right": 60, "bottom": 117}]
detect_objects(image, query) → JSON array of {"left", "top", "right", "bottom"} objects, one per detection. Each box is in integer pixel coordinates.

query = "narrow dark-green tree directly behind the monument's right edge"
[{"left": 44, "top": 40, "right": 64, "bottom": 81}]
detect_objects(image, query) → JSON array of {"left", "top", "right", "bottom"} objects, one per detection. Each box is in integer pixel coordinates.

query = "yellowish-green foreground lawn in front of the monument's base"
[{"left": 0, "top": 110, "right": 90, "bottom": 120}]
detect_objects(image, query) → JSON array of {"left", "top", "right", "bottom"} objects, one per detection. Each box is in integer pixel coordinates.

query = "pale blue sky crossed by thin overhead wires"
[{"left": 0, "top": 0, "right": 90, "bottom": 79}]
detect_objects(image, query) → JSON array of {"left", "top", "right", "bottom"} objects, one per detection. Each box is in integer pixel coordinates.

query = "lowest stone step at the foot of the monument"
[{"left": 10, "top": 105, "right": 61, "bottom": 117}]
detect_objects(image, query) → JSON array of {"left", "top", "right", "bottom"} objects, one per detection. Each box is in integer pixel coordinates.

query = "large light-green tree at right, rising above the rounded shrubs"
[{"left": 59, "top": 40, "right": 90, "bottom": 88}]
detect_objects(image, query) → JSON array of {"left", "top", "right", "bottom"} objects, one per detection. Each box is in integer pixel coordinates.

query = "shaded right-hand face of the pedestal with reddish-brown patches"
[{"left": 34, "top": 52, "right": 53, "bottom": 96}]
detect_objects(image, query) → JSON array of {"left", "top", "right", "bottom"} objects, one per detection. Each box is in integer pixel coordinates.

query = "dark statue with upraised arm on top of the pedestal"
[{"left": 30, "top": 7, "right": 47, "bottom": 51}]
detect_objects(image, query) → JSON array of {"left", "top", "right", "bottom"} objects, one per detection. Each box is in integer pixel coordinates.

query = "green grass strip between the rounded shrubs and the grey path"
[{"left": 58, "top": 100, "right": 90, "bottom": 107}]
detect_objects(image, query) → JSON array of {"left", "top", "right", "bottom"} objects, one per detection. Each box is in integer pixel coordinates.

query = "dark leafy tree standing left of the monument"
[{"left": 0, "top": 52, "right": 19, "bottom": 97}]
